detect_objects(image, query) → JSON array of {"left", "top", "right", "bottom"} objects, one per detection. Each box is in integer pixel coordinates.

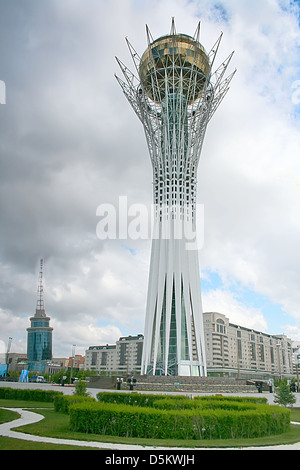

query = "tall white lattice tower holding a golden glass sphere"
[{"left": 116, "top": 19, "right": 235, "bottom": 376}]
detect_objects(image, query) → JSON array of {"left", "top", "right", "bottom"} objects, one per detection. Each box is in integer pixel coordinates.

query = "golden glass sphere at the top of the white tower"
[{"left": 139, "top": 34, "right": 210, "bottom": 104}]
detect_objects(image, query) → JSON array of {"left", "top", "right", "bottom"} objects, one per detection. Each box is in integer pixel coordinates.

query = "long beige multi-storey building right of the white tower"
[{"left": 203, "top": 312, "right": 294, "bottom": 378}]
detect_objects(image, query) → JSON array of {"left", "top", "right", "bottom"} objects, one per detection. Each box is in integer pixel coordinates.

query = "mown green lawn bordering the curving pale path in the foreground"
[{"left": 0, "top": 400, "right": 300, "bottom": 450}]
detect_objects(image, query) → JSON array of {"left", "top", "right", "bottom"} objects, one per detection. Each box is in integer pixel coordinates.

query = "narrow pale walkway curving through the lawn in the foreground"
[{"left": 0, "top": 407, "right": 300, "bottom": 452}]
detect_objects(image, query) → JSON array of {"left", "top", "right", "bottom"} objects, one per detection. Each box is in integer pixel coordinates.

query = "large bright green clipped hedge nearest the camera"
[{"left": 69, "top": 394, "right": 290, "bottom": 439}]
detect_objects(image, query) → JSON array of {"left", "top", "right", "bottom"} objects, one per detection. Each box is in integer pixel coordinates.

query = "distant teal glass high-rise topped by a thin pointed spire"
[{"left": 27, "top": 259, "right": 53, "bottom": 371}]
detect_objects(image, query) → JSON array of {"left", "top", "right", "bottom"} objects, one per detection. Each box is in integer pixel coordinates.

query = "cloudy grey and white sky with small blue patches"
[{"left": 0, "top": 0, "right": 300, "bottom": 356}]
